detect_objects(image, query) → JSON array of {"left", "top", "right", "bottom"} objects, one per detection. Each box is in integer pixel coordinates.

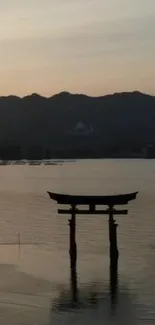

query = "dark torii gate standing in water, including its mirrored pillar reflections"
[{"left": 48, "top": 192, "right": 138, "bottom": 304}]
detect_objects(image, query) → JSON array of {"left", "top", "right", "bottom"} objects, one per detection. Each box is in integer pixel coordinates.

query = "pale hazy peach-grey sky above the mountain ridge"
[{"left": 0, "top": 0, "right": 155, "bottom": 96}]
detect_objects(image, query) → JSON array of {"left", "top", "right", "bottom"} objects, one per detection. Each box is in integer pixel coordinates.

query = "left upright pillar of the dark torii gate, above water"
[{"left": 69, "top": 205, "right": 77, "bottom": 270}]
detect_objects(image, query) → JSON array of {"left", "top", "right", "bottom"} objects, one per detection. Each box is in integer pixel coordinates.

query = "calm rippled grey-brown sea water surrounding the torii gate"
[{"left": 0, "top": 159, "right": 155, "bottom": 325}]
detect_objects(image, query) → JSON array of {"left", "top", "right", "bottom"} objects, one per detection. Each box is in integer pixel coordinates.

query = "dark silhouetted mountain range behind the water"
[{"left": 0, "top": 92, "right": 155, "bottom": 157}]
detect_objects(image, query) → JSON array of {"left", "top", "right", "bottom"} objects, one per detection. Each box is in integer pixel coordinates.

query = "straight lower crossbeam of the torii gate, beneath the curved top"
[{"left": 58, "top": 209, "right": 128, "bottom": 215}]
